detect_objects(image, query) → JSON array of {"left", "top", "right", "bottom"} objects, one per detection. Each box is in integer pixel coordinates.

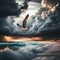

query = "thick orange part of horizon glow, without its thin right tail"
[{"left": 2, "top": 36, "right": 43, "bottom": 42}]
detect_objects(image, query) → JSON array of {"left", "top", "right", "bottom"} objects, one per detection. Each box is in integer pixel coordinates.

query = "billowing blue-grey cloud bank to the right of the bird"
[{"left": 28, "top": 2, "right": 60, "bottom": 35}]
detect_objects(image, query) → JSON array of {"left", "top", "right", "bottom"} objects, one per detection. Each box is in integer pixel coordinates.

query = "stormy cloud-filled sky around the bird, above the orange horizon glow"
[{"left": 0, "top": 0, "right": 60, "bottom": 36}]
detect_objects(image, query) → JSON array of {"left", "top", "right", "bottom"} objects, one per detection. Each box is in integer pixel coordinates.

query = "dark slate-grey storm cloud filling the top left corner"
[{"left": 0, "top": 0, "right": 30, "bottom": 17}]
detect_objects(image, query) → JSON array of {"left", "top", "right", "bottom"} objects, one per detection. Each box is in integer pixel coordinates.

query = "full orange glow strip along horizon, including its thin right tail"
[{"left": 2, "top": 36, "right": 60, "bottom": 42}]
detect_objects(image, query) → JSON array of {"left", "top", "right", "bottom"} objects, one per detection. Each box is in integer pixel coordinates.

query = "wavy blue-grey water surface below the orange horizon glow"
[{"left": 0, "top": 41, "right": 60, "bottom": 60}]
